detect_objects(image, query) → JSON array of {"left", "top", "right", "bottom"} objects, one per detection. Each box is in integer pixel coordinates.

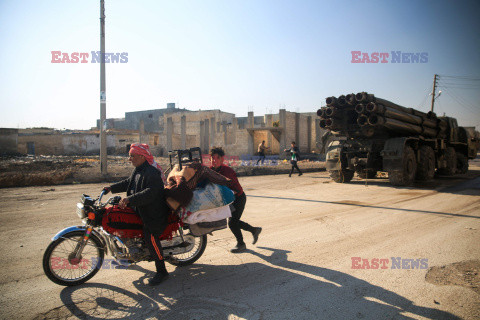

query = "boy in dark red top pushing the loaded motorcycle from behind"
[{"left": 210, "top": 148, "right": 262, "bottom": 253}]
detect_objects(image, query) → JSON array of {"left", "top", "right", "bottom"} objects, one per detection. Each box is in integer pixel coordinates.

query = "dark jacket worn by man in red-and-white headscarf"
[{"left": 111, "top": 161, "right": 169, "bottom": 236}]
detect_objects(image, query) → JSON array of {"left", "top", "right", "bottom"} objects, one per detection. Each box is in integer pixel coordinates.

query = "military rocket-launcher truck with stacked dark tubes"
[{"left": 317, "top": 92, "right": 478, "bottom": 186}]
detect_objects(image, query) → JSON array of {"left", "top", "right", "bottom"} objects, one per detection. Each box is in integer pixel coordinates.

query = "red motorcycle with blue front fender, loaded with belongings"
[{"left": 43, "top": 191, "right": 207, "bottom": 286}]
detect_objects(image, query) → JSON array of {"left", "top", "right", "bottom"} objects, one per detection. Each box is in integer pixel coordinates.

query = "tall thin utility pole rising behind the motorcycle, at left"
[{"left": 100, "top": 0, "right": 107, "bottom": 175}]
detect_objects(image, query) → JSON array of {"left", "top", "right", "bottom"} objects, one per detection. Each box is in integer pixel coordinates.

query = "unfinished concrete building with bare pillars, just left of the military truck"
[{"left": 159, "top": 109, "right": 323, "bottom": 156}]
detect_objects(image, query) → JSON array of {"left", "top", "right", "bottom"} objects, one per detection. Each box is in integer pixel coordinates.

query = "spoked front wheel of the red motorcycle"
[{"left": 43, "top": 231, "right": 104, "bottom": 286}]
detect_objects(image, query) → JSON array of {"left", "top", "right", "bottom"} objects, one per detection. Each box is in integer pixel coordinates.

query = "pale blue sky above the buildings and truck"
[{"left": 0, "top": 0, "right": 480, "bottom": 129}]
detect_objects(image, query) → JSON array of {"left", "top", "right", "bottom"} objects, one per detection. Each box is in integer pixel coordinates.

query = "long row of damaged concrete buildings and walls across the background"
[{"left": 0, "top": 103, "right": 324, "bottom": 156}]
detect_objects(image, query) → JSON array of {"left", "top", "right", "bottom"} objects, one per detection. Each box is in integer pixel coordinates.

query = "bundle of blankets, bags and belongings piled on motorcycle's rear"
[{"left": 165, "top": 162, "right": 235, "bottom": 236}]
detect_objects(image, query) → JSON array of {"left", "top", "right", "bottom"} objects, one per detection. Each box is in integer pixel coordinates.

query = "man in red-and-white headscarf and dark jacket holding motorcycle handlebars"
[{"left": 104, "top": 143, "right": 169, "bottom": 286}]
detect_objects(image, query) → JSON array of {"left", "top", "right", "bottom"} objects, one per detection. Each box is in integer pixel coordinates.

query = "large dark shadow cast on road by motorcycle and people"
[{"left": 45, "top": 247, "right": 459, "bottom": 320}]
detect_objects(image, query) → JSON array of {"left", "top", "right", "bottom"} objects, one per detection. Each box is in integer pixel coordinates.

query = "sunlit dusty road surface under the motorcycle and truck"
[{"left": 0, "top": 162, "right": 480, "bottom": 319}]
